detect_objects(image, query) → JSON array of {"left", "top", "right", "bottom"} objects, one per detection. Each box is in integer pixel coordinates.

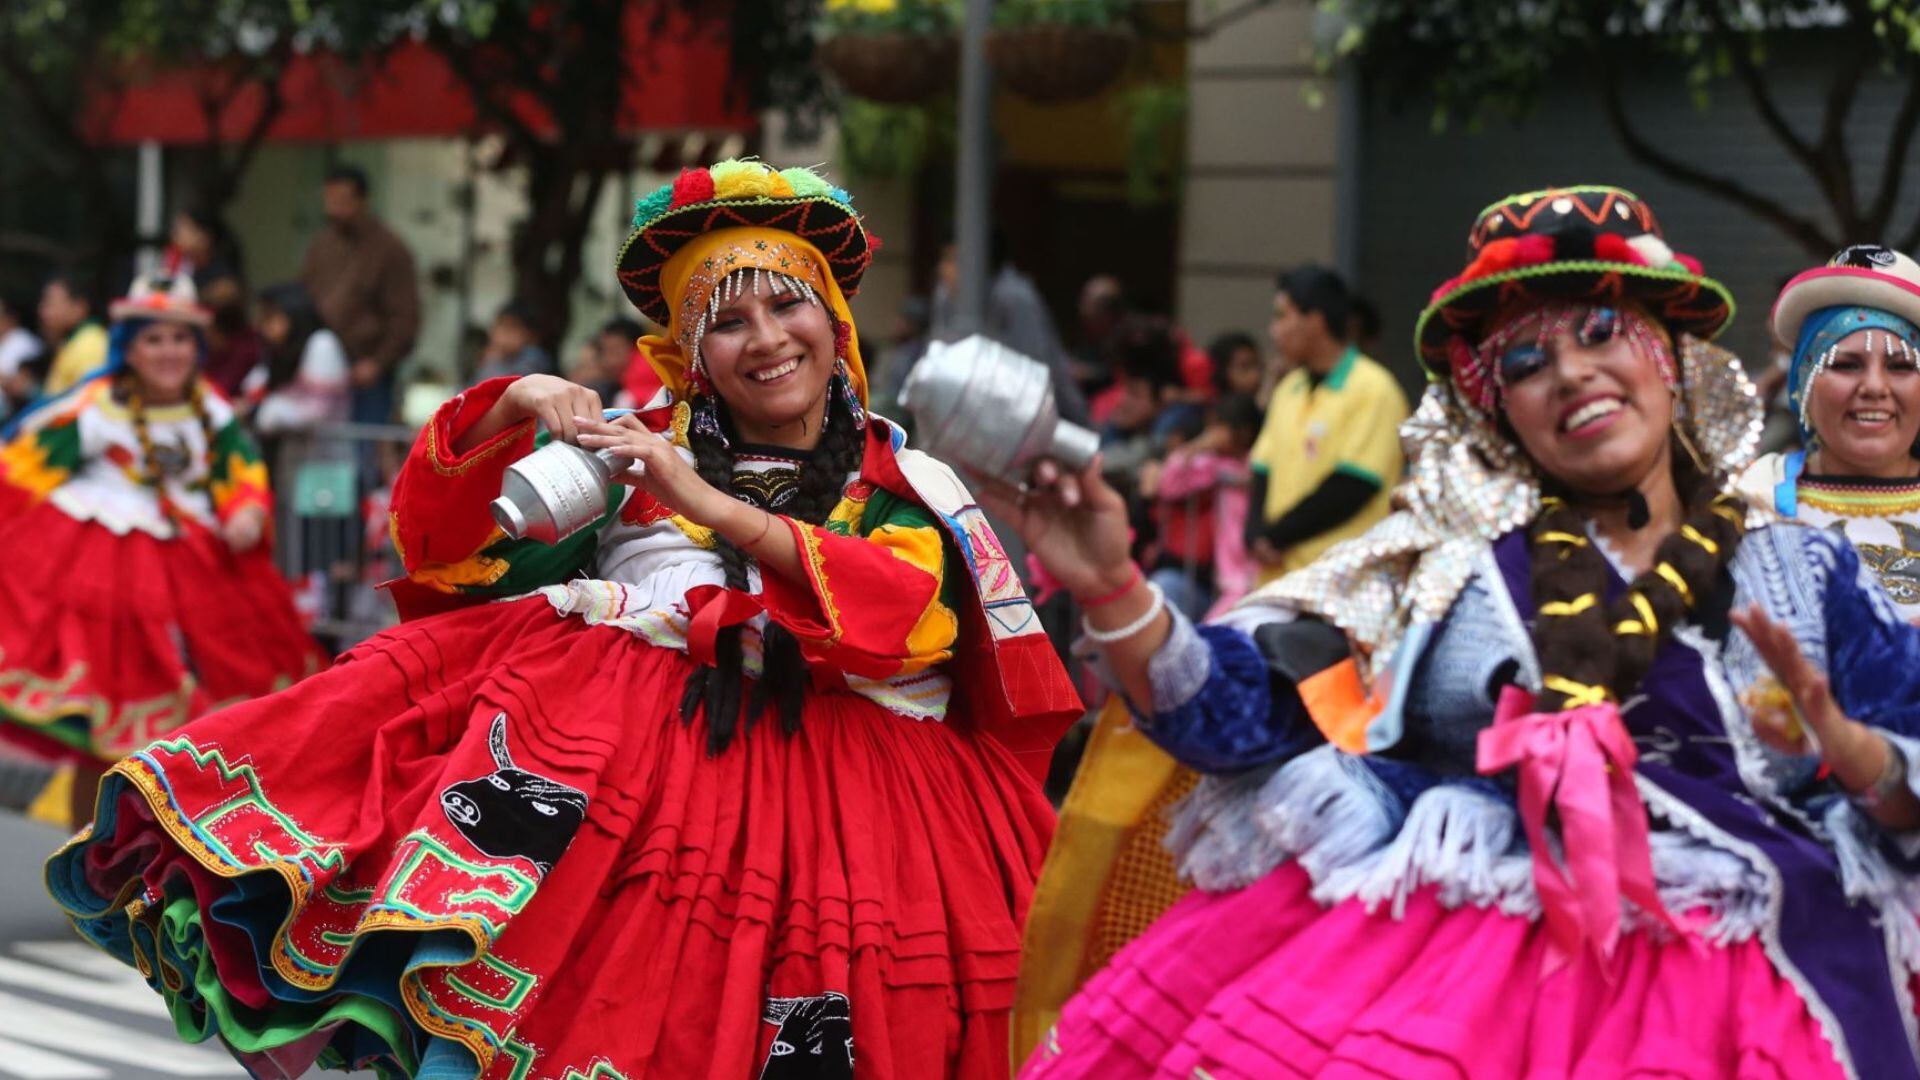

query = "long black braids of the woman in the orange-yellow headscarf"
[{"left": 680, "top": 375, "right": 864, "bottom": 753}]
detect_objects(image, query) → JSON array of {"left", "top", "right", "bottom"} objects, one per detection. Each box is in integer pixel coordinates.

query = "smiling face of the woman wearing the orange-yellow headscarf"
[{"left": 701, "top": 275, "right": 833, "bottom": 450}]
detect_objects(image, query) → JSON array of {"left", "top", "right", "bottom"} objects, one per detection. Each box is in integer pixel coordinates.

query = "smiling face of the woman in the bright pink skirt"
[{"left": 1496, "top": 305, "right": 1674, "bottom": 496}]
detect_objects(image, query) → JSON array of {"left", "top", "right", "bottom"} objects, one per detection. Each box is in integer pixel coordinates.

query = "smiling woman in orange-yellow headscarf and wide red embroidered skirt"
[{"left": 48, "top": 161, "right": 1079, "bottom": 1080}]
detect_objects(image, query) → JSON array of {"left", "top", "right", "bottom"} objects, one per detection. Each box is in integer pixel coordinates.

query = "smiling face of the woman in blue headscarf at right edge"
[{"left": 1807, "top": 331, "right": 1920, "bottom": 477}]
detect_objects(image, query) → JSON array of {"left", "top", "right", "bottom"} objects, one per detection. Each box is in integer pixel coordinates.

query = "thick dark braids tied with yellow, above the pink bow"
[{"left": 1530, "top": 432, "right": 1745, "bottom": 713}]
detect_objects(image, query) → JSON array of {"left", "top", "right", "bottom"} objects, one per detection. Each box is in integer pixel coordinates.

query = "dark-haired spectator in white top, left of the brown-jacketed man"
[{"left": 250, "top": 282, "right": 351, "bottom": 436}]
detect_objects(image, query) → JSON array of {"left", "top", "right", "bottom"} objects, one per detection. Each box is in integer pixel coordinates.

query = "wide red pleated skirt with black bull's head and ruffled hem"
[{"left": 50, "top": 596, "right": 1052, "bottom": 1080}]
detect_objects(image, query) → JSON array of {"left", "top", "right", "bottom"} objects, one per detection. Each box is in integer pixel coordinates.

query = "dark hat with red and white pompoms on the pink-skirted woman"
[{"left": 1413, "top": 186, "right": 1734, "bottom": 382}]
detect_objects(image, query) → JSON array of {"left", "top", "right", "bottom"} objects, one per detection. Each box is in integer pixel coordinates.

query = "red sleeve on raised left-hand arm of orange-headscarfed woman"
[{"left": 392, "top": 379, "right": 534, "bottom": 573}]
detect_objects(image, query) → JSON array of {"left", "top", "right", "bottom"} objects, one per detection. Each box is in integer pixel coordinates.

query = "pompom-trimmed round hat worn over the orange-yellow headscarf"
[{"left": 618, "top": 160, "right": 877, "bottom": 327}]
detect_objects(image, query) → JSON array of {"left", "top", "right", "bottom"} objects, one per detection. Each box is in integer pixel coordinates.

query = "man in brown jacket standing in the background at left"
[{"left": 300, "top": 165, "right": 420, "bottom": 423}]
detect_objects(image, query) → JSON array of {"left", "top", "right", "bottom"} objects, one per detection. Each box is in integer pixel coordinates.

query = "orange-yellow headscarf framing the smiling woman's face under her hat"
[{"left": 637, "top": 225, "right": 866, "bottom": 405}]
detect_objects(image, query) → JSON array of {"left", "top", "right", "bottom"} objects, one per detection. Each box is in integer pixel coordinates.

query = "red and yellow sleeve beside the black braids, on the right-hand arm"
[{"left": 760, "top": 517, "right": 960, "bottom": 678}]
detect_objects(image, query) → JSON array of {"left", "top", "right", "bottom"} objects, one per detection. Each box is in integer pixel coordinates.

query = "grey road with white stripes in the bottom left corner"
[{"left": 0, "top": 813, "right": 246, "bottom": 1080}]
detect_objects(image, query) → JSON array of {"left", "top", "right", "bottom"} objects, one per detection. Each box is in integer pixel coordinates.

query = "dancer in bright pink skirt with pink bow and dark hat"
[{"left": 993, "top": 186, "right": 1920, "bottom": 1080}]
